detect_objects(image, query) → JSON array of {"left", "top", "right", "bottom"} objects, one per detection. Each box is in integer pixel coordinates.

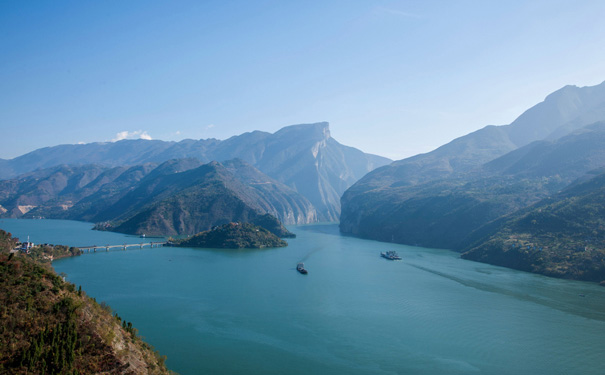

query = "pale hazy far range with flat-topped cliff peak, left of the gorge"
[{"left": 0, "top": 122, "right": 391, "bottom": 221}]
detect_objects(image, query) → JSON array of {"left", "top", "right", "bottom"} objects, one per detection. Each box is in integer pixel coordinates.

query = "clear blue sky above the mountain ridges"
[{"left": 0, "top": 0, "right": 605, "bottom": 160}]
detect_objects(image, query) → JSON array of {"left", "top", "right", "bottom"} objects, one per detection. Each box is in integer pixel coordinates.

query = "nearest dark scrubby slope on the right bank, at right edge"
[{"left": 462, "top": 170, "right": 605, "bottom": 284}]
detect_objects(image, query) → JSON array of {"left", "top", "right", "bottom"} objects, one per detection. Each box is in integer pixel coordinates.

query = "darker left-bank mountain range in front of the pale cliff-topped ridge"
[{"left": 0, "top": 159, "right": 317, "bottom": 236}]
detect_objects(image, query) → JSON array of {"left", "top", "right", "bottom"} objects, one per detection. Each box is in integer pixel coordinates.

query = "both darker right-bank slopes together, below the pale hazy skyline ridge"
[{"left": 340, "top": 122, "right": 605, "bottom": 281}]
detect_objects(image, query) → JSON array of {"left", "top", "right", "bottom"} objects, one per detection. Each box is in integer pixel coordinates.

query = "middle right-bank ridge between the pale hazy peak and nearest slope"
[{"left": 340, "top": 123, "right": 605, "bottom": 250}]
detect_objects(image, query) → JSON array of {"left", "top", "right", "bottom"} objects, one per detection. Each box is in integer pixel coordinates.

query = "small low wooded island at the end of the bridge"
[{"left": 173, "top": 223, "right": 288, "bottom": 249}]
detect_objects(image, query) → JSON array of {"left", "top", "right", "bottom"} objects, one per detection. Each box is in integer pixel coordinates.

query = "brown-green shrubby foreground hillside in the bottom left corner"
[{"left": 0, "top": 230, "right": 175, "bottom": 374}]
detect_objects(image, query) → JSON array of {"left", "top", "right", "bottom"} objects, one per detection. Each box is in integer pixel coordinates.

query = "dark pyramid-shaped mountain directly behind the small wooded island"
[{"left": 99, "top": 161, "right": 306, "bottom": 235}]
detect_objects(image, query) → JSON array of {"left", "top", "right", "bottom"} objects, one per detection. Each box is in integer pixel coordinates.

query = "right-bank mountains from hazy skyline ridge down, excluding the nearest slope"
[{"left": 340, "top": 84, "right": 605, "bottom": 268}]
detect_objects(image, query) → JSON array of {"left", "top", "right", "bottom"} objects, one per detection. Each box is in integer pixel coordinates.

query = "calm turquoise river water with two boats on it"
[{"left": 0, "top": 220, "right": 605, "bottom": 375}]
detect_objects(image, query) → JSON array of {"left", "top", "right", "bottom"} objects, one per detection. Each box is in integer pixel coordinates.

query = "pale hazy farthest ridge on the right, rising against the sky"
[{"left": 344, "top": 82, "right": 605, "bottom": 191}]
